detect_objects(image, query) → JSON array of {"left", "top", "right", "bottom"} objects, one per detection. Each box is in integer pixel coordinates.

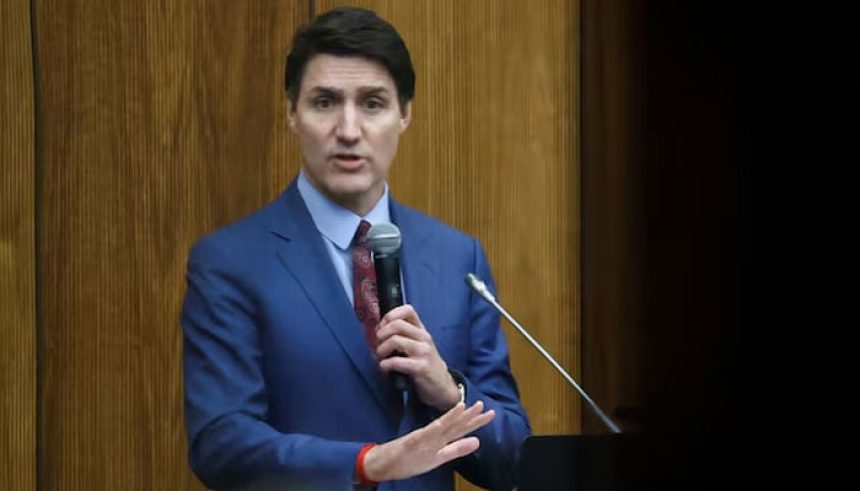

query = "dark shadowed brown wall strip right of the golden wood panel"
[{"left": 582, "top": 0, "right": 645, "bottom": 433}]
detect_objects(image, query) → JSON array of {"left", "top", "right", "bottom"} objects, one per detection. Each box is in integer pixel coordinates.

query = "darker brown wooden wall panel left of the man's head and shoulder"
[{"left": 34, "top": 0, "right": 308, "bottom": 490}]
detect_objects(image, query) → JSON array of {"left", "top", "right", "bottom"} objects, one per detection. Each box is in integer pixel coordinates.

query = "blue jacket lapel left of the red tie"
[{"left": 272, "top": 181, "right": 388, "bottom": 416}]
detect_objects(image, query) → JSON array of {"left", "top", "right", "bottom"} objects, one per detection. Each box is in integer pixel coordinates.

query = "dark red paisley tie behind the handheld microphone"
[{"left": 352, "top": 220, "right": 379, "bottom": 353}]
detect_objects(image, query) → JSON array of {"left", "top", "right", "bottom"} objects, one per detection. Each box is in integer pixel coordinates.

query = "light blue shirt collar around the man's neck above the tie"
[{"left": 297, "top": 169, "right": 391, "bottom": 251}]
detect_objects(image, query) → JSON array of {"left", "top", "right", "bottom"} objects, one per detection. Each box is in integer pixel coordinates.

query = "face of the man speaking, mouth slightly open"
[{"left": 289, "top": 55, "right": 412, "bottom": 216}]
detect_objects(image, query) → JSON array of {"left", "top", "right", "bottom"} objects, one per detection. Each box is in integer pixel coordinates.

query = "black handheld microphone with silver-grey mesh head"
[{"left": 367, "top": 223, "right": 408, "bottom": 391}]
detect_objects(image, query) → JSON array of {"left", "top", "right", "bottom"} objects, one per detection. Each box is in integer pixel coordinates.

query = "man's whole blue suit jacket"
[{"left": 182, "top": 181, "right": 530, "bottom": 490}]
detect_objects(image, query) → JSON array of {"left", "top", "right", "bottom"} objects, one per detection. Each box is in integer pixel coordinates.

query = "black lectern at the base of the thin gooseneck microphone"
[{"left": 517, "top": 433, "right": 648, "bottom": 491}]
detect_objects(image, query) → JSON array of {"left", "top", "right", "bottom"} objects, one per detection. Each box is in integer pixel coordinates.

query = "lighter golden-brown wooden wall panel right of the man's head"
[{"left": 316, "top": 0, "right": 579, "bottom": 444}]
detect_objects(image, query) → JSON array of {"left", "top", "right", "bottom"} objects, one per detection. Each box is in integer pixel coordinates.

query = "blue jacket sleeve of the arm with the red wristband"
[{"left": 182, "top": 239, "right": 361, "bottom": 489}]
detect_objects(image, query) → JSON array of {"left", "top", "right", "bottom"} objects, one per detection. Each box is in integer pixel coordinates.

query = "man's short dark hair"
[{"left": 284, "top": 7, "right": 415, "bottom": 106}]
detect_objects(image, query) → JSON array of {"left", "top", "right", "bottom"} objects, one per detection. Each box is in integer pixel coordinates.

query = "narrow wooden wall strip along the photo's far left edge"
[{"left": 0, "top": 0, "right": 37, "bottom": 489}]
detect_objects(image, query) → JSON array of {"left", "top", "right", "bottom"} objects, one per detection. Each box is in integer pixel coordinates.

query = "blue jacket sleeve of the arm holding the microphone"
[{"left": 454, "top": 240, "right": 531, "bottom": 490}]
